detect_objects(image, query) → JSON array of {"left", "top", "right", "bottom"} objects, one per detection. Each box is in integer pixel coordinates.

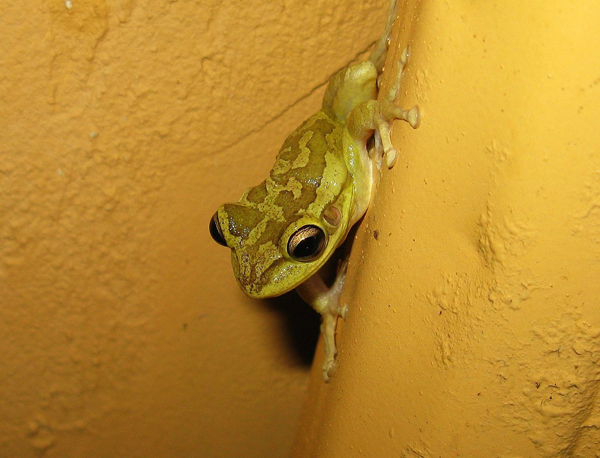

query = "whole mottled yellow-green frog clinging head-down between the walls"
[{"left": 209, "top": 0, "right": 420, "bottom": 382}]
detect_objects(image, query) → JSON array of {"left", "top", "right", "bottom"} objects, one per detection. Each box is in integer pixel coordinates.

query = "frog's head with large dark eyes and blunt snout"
[{"left": 210, "top": 191, "right": 347, "bottom": 298}]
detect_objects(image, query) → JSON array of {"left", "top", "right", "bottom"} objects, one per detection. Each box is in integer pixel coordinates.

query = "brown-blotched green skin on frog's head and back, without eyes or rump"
[{"left": 218, "top": 104, "right": 355, "bottom": 298}]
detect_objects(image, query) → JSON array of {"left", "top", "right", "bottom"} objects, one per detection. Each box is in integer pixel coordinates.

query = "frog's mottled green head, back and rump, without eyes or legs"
[{"left": 217, "top": 45, "right": 392, "bottom": 296}]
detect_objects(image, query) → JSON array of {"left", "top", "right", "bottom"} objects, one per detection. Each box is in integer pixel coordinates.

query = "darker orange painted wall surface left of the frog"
[{"left": 0, "top": 0, "right": 387, "bottom": 458}]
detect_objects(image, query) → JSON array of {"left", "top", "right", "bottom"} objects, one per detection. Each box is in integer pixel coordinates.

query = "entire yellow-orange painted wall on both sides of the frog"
[{"left": 0, "top": 0, "right": 600, "bottom": 458}]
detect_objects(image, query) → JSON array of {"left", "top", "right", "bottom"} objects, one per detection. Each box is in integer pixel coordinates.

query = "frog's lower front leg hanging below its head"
[{"left": 296, "top": 260, "right": 348, "bottom": 382}]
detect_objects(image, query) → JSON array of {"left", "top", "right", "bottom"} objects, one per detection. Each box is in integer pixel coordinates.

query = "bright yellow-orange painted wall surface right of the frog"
[{"left": 294, "top": 0, "right": 600, "bottom": 458}]
